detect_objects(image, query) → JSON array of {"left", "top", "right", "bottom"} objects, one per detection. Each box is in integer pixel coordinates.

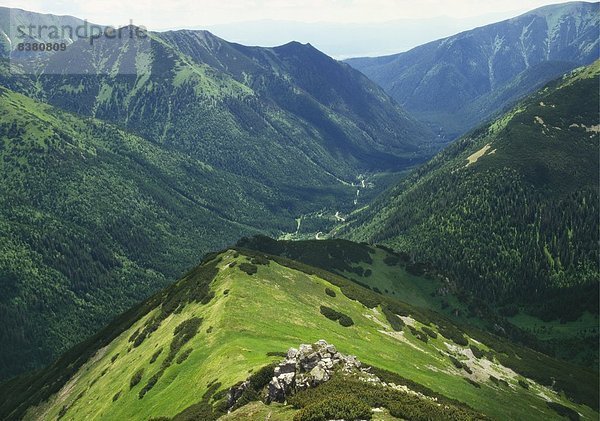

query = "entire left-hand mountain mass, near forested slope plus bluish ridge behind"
[{"left": 0, "top": 11, "right": 431, "bottom": 378}]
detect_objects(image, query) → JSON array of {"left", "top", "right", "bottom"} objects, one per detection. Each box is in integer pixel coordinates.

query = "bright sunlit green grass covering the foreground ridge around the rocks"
[{"left": 3, "top": 251, "right": 593, "bottom": 419}]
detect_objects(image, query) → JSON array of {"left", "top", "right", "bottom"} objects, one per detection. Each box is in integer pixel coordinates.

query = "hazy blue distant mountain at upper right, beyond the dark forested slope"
[{"left": 347, "top": 2, "right": 600, "bottom": 140}]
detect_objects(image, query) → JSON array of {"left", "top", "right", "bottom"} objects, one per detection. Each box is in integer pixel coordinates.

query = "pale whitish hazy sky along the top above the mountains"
[{"left": 0, "top": 0, "right": 580, "bottom": 30}]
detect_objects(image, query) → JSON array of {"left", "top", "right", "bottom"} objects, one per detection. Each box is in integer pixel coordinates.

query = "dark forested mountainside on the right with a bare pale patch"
[{"left": 340, "top": 61, "right": 600, "bottom": 354}]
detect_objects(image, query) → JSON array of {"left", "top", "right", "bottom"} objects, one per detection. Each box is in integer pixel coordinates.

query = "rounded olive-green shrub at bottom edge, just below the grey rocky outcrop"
[{"left": 294, "top": 396, "right": 372, "bottom": 421}]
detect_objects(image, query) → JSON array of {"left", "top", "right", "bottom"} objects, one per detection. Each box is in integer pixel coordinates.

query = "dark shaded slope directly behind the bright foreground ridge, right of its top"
[{"left": 238, "top": 235, "right": 597, "bottom": 368}]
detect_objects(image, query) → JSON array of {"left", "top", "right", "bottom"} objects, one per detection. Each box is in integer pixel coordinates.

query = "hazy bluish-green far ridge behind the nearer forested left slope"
[{"left": 4, "top": 23, "right": 433, "bottom": 173}]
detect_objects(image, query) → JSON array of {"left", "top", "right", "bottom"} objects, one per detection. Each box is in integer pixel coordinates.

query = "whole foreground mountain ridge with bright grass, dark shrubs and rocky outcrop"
[{"left": 0, "top": 242, "right": 598, "bottom": 420}]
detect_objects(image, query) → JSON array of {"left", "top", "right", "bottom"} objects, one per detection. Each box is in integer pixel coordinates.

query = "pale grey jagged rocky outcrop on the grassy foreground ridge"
[{"left": 266, "top": 340, "right": 368, "bottom": 402}]
